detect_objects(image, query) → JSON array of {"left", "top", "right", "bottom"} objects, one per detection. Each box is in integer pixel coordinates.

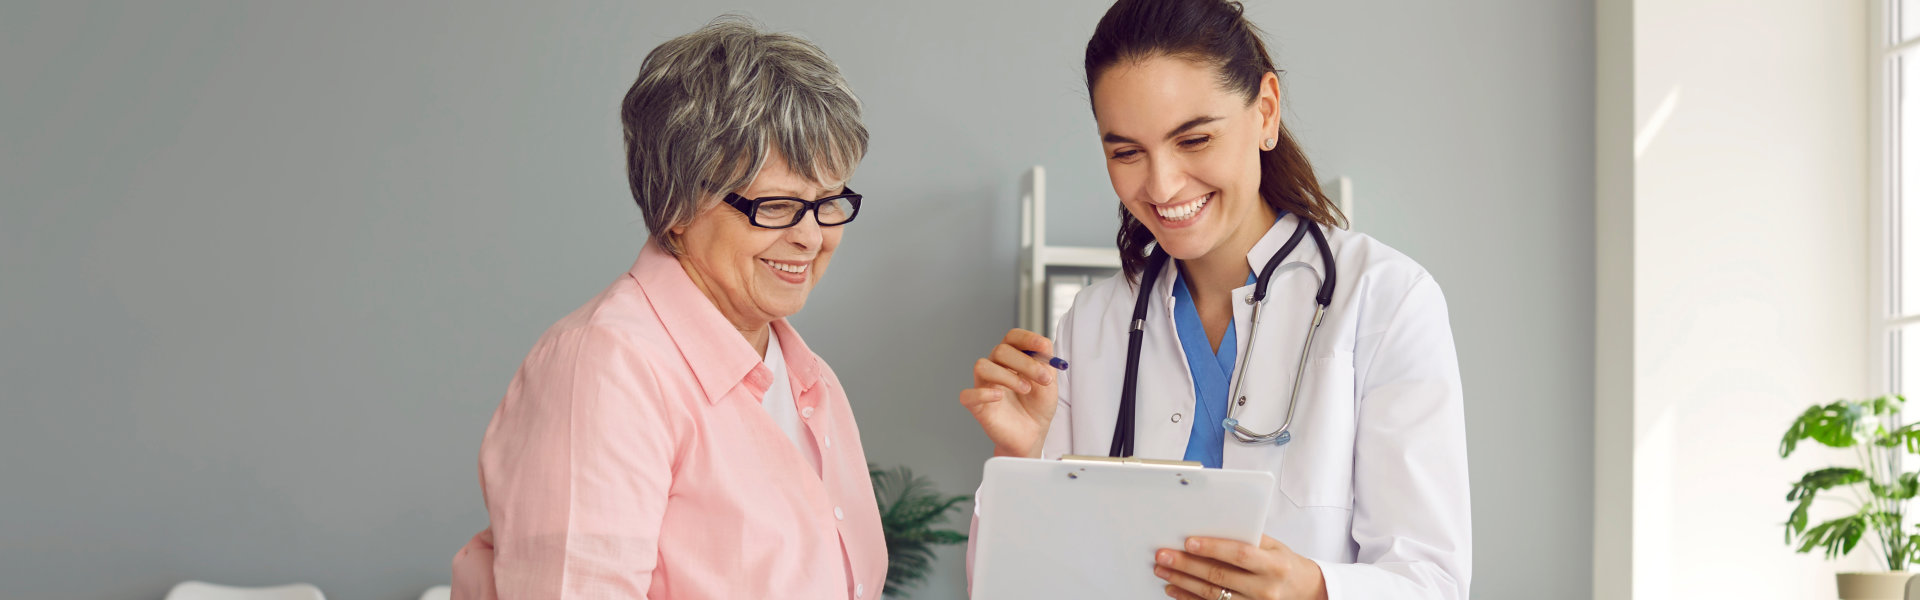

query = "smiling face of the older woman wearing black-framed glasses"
[{"left": 674, "top": 150, "right": 843, "bottom": 331}]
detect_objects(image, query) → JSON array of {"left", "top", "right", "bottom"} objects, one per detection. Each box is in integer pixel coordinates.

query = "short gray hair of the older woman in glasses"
[{"left": 620, "top": 15, "right": 866, "bottom": 256}]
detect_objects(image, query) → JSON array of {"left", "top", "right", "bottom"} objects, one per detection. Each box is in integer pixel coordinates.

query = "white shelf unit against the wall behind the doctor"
[{"left": 1018, "top": 165, "right": 1354, "bottom": 337}]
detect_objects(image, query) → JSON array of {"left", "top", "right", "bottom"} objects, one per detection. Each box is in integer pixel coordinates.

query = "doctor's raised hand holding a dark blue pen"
[{"left": 960, "top": 329, "right": 1060, "bottom": 458}]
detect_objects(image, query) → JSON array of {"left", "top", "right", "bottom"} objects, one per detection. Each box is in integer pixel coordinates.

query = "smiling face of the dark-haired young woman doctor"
[{"left": 1092, "top": 56, "right": 1281, "bottom": 260}]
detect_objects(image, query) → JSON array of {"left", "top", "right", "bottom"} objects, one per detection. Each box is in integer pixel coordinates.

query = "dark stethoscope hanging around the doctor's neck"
[{"left": 1106, "top": 219, "right": 1334, "bottom": 458}]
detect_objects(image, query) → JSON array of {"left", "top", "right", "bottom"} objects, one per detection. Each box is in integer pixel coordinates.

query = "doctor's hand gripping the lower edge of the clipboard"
[{"left": 1154, "top": 537, "right": 1327, "bottom": 600}]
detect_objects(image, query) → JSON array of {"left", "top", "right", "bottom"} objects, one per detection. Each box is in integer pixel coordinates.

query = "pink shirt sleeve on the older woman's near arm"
[{"left": 480, "top": 327, "right": 687, "bottom": 600}]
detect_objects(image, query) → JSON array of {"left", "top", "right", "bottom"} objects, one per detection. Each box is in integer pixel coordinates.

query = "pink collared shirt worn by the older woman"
[{"left": 453, "top": 242, "right": 887, "bottom": 600}]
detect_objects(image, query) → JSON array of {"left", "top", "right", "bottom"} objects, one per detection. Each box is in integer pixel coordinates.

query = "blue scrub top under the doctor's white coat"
[{"left": 1173, "top": 269, "right": 1256, "bottom": 469}]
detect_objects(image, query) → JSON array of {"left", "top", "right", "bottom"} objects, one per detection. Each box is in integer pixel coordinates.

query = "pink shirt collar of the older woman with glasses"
[{"left": 628, "top": 240, "right": 820, "bottom": 404}]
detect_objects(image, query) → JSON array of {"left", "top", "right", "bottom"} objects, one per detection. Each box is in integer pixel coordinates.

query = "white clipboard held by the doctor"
[{"left": 972, "top": 456, "right": 1273, "bottom": 598}]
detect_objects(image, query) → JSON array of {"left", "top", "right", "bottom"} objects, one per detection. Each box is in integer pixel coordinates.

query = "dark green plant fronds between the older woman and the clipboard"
[{"left": 868, "top": 467, "right": 972, "bottom": 598}]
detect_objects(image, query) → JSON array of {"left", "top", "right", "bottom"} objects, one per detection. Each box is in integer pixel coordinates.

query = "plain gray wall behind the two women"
[{"left": 0, "top": 0, "right": 1594, "bottom": 600}]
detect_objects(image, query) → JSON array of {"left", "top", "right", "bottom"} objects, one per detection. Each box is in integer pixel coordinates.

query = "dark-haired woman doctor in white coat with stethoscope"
[{"left": 960, "top": 0, "right": 1473, "bottom": 600}]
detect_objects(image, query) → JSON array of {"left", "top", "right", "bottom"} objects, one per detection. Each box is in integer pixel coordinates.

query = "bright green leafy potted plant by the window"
[{"left": 1780, "top": 396, "right": 1920, "bottom": 600}]
